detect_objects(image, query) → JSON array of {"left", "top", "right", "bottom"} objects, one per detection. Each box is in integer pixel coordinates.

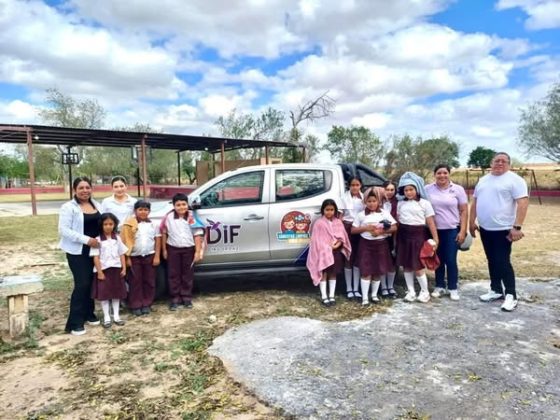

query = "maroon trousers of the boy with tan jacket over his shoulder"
[{"left": 128, "top": 254, "right": 156, "bottom": 309}]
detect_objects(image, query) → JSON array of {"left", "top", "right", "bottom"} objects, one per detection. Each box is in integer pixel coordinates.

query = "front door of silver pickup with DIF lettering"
[{"left": 196, "top": 170, "right": 270, "bottom": 269}]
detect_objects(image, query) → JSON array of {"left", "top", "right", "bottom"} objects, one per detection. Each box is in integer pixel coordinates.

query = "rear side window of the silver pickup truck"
[{"left": 276, "top": 169, "right": 332, "bottom": 201}]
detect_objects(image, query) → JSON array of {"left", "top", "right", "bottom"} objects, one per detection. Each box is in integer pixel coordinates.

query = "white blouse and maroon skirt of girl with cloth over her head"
[{"left": 397, "top": 198, "right": 435, "bottom": 271}]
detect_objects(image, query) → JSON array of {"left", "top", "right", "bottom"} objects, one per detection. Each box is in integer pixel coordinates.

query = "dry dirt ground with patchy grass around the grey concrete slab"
[{"left": 0, "top": 202, "right": 560, "bottom": 419}]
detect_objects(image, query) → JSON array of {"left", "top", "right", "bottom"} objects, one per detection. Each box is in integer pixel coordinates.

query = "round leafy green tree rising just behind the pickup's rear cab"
[{"left": 323, "top": 126, "right": 383, "bottom": 167}]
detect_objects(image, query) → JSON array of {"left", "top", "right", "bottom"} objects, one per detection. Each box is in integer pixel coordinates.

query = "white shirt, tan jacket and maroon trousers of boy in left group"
[{"left": 122, "top": 216, "right": 161, "bottom": 310}]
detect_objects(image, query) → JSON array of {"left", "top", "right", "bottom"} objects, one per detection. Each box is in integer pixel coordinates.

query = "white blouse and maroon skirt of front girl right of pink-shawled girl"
[{"left": 353, "top": 209, "right": 397, "bottom": 277}]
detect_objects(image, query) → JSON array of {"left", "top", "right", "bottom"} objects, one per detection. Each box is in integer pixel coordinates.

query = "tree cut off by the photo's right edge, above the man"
[{"left": 518, "top": 82, "right": 560, "bottom": 162}]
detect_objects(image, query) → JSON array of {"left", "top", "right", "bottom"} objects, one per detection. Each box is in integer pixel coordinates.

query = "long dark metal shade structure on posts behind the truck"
[{"left": 0, "top": 124, "right": 301, "bottom": 215}]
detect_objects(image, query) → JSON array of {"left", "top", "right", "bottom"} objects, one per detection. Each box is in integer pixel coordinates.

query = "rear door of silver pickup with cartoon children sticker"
[{"left": 268, "top": 169, "right": 338, "bottom": 265}]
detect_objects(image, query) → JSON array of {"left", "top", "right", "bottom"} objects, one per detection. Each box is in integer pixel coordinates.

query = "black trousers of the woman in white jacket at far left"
[{"left": 65, "top": 254, "right": 95, "bottom": 332}]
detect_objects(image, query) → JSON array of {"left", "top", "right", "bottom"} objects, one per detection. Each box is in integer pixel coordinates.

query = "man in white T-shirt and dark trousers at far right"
[{"left": 469, "top": 152, "right": 529, "bottom": 312}]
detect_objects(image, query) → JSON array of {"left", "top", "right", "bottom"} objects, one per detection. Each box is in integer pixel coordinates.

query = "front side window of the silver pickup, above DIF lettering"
[{"left": 200, "top": 171, "right": 264, "bottom": 208}]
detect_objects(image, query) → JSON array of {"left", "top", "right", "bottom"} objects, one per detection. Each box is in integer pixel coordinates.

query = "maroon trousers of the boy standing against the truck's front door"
[{"left": 167, "top": 245, "right": 195, "bottom": 303}]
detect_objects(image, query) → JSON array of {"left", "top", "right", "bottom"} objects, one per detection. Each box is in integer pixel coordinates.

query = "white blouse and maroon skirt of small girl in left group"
[{"left": 90, "top": 234, "right": 128, "bottom": 300}]
